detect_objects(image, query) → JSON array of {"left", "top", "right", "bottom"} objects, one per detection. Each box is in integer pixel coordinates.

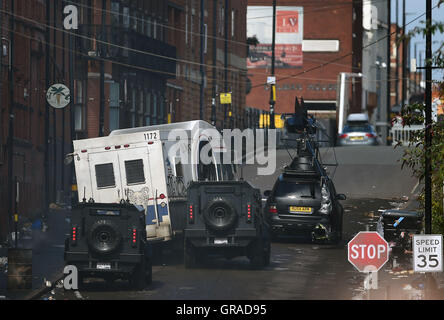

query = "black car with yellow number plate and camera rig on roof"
[{"left": 264, "top": 156, "right": 345, "bottom": 243}]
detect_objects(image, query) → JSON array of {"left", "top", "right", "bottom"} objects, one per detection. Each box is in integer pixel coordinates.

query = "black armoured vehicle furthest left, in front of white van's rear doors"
[{"left": 65, "top": 201, "right": 152, "bottom": 290}]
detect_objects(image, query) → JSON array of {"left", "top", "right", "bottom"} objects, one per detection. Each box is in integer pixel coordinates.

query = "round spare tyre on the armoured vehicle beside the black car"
[{"left": 203, "top": 197, "right": 238, "bottom": 231}]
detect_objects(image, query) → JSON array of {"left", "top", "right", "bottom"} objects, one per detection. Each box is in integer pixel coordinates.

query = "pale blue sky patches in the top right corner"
[{"left": 391, "top": 0, "right": 444, "bottom": 80}]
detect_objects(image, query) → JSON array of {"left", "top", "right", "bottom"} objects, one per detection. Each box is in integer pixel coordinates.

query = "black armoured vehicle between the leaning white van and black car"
[{"left": 184, "top": 181, "right": 270, "bottom": 268}]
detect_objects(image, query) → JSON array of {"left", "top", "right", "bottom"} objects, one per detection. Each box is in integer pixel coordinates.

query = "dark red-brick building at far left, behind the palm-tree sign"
[{"left": 0, "top": 0, "right": 74, "bottom": 241}]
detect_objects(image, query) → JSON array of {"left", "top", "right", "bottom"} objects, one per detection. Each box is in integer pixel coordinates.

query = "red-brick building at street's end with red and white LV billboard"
[{"left": 246, "top": 0, "right": 362, "bottom": 114}]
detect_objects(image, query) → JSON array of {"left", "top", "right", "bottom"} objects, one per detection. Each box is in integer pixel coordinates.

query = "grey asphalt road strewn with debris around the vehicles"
[{"left": 47, "top": 147, "right": 416, "bottom": 300}]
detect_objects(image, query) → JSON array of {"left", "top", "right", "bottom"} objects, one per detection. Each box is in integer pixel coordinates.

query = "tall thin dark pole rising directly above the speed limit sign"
[{"left": 424, "top": 0, "right": 432, "bottom": 234}]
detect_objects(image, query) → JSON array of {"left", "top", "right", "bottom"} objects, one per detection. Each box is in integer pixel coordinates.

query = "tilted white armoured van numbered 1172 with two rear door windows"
[{"left": 73, "top": 120, "right": 233, "bottom": 241}]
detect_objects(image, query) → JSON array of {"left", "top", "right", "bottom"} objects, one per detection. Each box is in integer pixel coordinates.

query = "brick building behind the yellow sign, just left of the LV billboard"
[{"left": 167, "top": 0, "right": 247, "bottom": 128}]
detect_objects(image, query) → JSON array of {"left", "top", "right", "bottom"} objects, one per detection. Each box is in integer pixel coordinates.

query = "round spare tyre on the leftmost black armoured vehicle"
[{"left": 88, "top": 220, "right": 122, "bottom": 254}]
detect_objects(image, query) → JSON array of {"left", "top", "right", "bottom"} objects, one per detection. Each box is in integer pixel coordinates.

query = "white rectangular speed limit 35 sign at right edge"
[{"left": 413, "top": 234, "right": 443, "bottom": 272}]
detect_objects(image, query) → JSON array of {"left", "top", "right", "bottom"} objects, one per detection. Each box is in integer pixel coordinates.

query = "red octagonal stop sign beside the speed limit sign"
[{"left": 348, "top": 231, "right": 389, "bottom": 272}]
